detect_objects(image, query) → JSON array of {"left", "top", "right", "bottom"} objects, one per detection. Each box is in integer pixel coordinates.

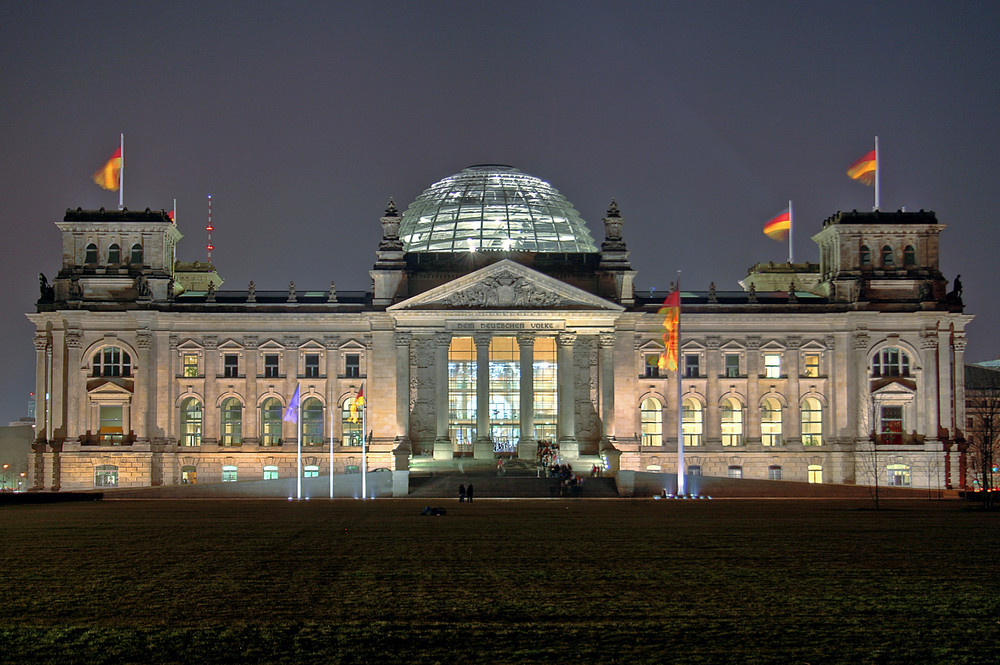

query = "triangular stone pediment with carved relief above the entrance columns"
[{"left": 388, "top": 259, "right": 624, "bottom": 312}]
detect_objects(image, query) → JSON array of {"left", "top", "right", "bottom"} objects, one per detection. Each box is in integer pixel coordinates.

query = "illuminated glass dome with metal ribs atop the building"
[{"left": 399, "top": 164, "right": 597, "bottom": 253}]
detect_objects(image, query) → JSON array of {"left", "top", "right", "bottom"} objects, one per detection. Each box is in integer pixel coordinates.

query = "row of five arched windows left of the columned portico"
[{"left": 179, "top": 397, "right": 361, "bottom": 446}]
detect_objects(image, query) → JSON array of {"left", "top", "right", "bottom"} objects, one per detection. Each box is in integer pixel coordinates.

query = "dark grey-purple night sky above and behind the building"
[{"left": 0, "top": 0, "right": 1000, "bottom": 424}]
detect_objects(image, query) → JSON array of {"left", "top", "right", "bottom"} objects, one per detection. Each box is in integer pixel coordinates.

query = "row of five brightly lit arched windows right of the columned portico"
[{"left": 640, "top": 397, "right": 823, "bottom": 446}]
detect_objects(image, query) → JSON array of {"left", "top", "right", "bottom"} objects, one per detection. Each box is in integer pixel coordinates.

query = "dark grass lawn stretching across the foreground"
[{"left": 0, "top": 500, "right": 1000, "bottom": 665}]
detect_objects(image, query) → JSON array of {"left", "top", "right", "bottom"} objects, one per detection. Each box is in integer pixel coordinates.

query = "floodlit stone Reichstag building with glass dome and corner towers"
[{"left": 28, "top": 165, "right": 972, "bottom": 490}]
